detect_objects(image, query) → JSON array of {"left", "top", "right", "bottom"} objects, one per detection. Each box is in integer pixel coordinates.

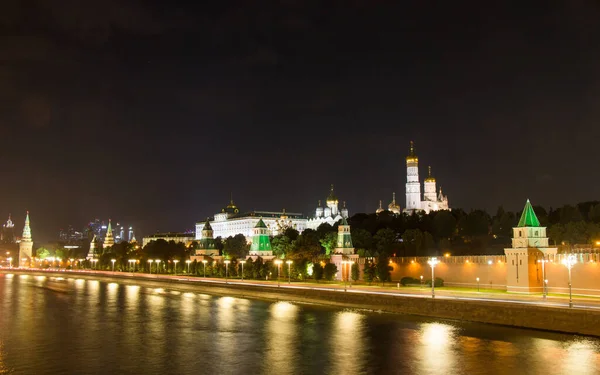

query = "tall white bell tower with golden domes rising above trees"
[{"left": 404, "top": 141, "right": 450, "bottom": 213}]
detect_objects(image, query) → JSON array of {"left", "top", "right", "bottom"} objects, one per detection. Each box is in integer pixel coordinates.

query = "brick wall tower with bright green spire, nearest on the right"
[{"left": 504, "top": 199, "right": 557, "bottom": 293}]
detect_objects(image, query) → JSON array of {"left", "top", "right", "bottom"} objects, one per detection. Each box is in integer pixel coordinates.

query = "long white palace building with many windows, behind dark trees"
[{"left": 196, "top": 200, "right": 307, "bottom": 241}]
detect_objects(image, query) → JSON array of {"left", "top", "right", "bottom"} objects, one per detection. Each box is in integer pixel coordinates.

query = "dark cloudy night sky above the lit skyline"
[{"left": 0, "top": 0, "right": 600, "bottom": 239}]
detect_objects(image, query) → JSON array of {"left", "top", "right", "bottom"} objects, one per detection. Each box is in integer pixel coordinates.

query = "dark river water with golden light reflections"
[{"left": 0, "top": 274, "right": 600, "bottom": 375}]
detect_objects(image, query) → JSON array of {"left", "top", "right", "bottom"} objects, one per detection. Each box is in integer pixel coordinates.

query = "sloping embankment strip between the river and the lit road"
[{"left": 0, "top": 269, "right": 600, "bottom": 337}]
